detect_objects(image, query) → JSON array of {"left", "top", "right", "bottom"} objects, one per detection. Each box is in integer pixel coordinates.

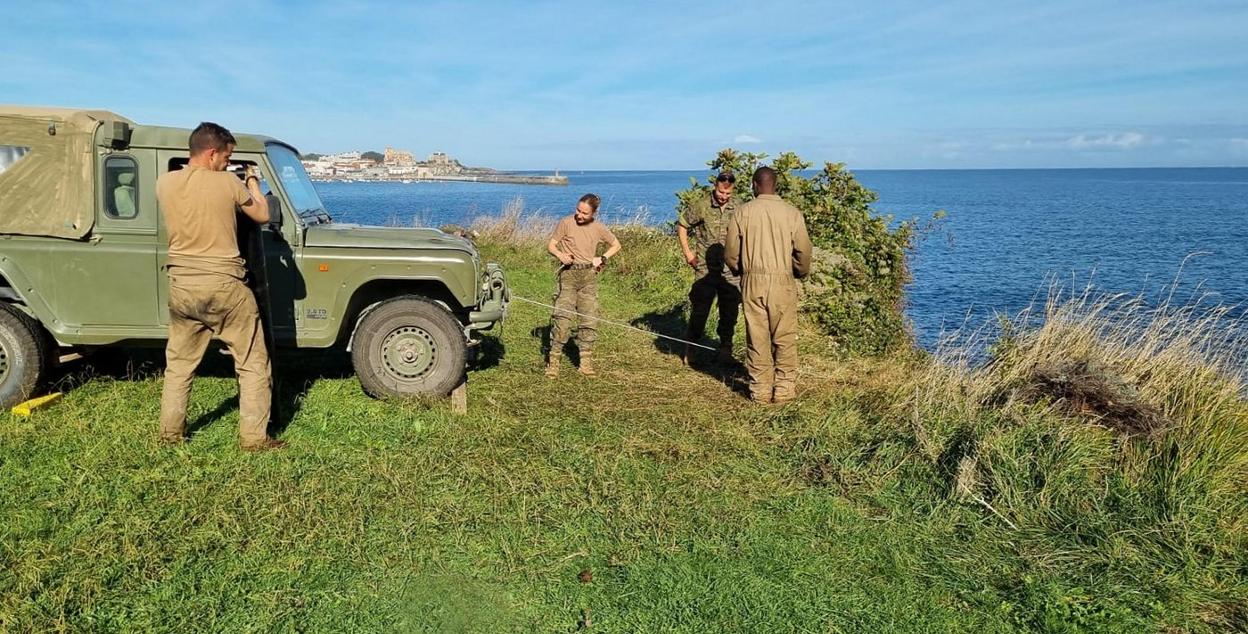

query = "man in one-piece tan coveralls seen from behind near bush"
[{"left": 724, "top": 167, "right": 814, "bottom": 403}]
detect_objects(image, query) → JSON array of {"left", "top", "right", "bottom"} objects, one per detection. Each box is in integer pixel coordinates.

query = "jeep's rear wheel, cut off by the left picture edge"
[{"left": 0, "top": 303, "right": 52, "bottom": 409}]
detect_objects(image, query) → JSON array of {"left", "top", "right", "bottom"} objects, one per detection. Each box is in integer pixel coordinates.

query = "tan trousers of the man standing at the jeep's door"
[{"left": 160, "top": 267, "right": 272, "bottom": 447}]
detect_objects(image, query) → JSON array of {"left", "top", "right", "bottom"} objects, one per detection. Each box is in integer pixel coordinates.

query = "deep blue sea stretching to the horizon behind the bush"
[{"left": 317, "top": 167, "right": 1248, "bottom": 347}]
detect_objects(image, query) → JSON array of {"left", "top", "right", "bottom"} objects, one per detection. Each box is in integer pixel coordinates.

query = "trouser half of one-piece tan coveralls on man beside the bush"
[{"left": 741, "top": 275, "right": 797, "bottom": 403}]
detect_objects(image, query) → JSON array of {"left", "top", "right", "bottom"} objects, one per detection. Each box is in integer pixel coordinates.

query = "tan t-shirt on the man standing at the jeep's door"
[{"left": 156, "top": 165, "right": 251, "bottom": 278}]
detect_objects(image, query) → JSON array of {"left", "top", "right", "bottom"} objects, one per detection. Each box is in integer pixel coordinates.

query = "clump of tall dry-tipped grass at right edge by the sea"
[{"left": 892, "top": 285, "right": 1248, "bottom": 628}]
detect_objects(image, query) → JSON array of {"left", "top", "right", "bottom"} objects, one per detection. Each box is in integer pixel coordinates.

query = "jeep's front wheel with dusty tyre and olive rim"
[{"left": 351, "top": 296, "right": 468, "bottom": 398}]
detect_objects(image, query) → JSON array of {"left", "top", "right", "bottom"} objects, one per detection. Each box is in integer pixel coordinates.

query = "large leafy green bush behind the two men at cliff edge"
[{"left": 676, "top": 149, "right": 941, "bottom": 354}]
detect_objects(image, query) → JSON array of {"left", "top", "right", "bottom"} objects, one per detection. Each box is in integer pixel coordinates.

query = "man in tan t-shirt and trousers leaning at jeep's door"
[{"left": 156, "top": 122, "right": 286, "bottom": 451}]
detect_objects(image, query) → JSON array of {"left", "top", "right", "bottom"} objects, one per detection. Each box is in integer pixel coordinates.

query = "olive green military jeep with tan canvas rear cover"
[{"left": 0, "top": 106, "right": 508, "bottom": 407}]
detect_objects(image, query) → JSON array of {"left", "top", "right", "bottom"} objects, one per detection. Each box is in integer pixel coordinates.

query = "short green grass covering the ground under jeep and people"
[{"left": 0, "top": 230, "right": 1248, "bottom": 632}]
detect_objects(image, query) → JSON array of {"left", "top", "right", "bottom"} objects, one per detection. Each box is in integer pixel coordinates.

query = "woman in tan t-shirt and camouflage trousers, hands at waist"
[{"left": 545, "top": 193, "right": 620, "bottom": 378}]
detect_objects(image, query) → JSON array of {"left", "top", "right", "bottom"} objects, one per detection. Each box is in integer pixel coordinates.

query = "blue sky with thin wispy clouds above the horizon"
[{"left": 0, "top": 0, "right": 1248, "bottom": 170}]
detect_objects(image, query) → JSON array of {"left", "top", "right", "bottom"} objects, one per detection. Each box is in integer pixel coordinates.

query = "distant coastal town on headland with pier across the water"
[{"left": 301, "top": 147, "right": 568, "bottom": 185}]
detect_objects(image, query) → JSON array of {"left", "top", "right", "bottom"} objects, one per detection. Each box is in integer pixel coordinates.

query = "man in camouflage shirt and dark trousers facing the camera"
[{"left": 676, "top": 171, "right": 741, "bottom": 363}]
